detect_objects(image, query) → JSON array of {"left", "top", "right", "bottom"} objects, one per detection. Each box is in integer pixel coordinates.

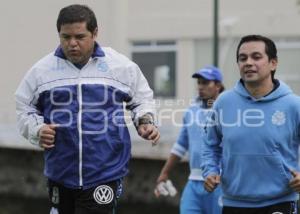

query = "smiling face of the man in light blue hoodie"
[{"left": 238, "top": 41, "right": 277, "bottom": 84}]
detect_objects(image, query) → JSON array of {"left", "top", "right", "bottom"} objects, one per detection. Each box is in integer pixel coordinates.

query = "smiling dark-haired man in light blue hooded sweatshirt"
[{"left": 202, "top": 35, "right": 300, "bottom": 214}]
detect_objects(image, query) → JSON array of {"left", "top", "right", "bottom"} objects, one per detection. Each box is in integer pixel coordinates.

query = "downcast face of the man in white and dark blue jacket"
[{"left": 59, "top": 22, "right": 97, "bottom": 64}]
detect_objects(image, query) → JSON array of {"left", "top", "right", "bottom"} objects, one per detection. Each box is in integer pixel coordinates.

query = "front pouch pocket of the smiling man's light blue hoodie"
[{"left": 222, "top": 154, "right": 291, "bottom": 201}]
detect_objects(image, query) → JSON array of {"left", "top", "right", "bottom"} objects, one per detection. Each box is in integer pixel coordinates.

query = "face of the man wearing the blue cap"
[{"left": 197, "top": 77, "right": 220, "bottom": 100}]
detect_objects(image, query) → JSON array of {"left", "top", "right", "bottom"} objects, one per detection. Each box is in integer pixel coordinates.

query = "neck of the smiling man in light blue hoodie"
[{"left": 245, "top": 81, "right": 274, "bottom": 99}]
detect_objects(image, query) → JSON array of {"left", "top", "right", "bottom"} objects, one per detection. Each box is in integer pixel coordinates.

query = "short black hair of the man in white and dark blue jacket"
[{"left": 56, "top": 4, "right": 97, "bottom": 33}]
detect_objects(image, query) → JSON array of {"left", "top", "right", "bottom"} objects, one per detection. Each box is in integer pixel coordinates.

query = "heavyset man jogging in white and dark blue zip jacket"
[{"left": 16, "top": 5, "right": 159, "bottom": 214}]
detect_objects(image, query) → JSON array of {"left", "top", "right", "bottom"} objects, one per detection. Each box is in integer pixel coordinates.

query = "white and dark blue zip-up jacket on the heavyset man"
[{"left": 15, "top": 44, "right": 154, "bottom": 189}]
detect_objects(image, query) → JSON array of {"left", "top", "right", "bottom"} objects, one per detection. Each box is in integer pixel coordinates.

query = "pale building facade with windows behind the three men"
[{"left": 0, "top": 0, "right": 300, "bottom": 155}]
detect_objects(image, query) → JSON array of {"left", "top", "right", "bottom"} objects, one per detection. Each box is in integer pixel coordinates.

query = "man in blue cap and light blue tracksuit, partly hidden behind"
[{"left": 155, "top": 66, "right": 224, "bottom": 214}]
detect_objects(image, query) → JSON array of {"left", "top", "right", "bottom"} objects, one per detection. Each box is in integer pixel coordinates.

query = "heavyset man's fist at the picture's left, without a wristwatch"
[{"left": 39, "top": 124, "right": 58, "bottom": 149}]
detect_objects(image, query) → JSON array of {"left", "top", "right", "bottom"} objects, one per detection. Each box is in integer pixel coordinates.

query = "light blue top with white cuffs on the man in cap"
[{"left": 171, "top": 98, "right": 210, "bottom": 181}]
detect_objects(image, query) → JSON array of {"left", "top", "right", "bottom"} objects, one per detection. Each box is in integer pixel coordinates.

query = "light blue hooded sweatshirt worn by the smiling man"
[{"left": 202, "top": 81, "right": 300, "bottom": 207}]
